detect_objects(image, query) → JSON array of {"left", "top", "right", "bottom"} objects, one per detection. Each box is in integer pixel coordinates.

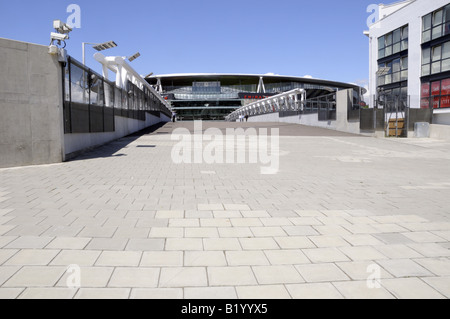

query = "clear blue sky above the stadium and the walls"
[{"left": 0, "top": 0, "right": 380, "bottom": 84}]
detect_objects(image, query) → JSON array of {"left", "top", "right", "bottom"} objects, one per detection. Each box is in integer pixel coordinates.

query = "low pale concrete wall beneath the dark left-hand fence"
[{"left": 64, "top": 113, "right": 168, "bottom": 160}]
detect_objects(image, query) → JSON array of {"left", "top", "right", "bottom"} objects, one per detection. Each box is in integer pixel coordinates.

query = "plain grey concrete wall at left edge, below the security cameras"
[{"left": 0, "top": 38, "right": 64, "bottom": 167}]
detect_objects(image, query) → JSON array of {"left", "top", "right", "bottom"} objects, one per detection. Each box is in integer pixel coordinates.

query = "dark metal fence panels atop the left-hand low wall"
[{"left": 64, "top": 57, "right": 171, "bottom": 134}]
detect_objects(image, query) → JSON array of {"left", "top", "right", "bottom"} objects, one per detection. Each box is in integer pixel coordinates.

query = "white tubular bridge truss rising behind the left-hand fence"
[{"left": 94, "top": 52, "right": 172, "bottom": 111}]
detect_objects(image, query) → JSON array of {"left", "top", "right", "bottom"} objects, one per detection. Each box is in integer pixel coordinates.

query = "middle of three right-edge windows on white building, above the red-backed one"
[{"left": 422, "top": 41, "right": 450, "bottom": 76}]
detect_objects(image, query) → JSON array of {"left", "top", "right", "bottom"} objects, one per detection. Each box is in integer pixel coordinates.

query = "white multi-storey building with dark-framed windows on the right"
[{"left": 365, "top": 0, "right": 450, "bottom": 124}]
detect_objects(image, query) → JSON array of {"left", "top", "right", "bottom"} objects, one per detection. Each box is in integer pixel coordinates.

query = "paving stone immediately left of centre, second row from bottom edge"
[{"left": 158, "top": 267, "right": 207, "bottom": 288}]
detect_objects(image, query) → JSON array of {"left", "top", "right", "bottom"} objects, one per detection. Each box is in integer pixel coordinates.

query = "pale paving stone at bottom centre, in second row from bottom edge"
[{"left": 208, "top": 266, "right": 257, "bottom": 286}]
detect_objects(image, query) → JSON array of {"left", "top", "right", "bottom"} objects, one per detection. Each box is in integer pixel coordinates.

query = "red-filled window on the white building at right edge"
[{"left": 420, "top": 79, "right": 450, "bottom": 109}]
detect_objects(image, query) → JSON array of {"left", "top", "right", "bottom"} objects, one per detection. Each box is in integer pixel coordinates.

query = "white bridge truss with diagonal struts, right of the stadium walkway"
[{"left": 226, "top": 89, "right": 306, "bottom": 121}]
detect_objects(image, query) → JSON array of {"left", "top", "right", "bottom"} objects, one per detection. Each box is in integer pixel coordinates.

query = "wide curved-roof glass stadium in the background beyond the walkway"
[{"left": 146, "top": 74, "right": 361, "bottom": 120}]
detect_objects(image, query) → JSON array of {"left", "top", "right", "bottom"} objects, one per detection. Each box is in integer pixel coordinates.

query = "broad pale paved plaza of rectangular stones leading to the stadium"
[{"left": 0, "top": 123, "right": 450, "bottom": 299}]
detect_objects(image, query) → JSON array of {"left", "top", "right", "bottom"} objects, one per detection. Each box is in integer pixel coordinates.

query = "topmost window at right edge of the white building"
[{"left": 422, "top": 5, "right": 450, "bottom": 43}]
